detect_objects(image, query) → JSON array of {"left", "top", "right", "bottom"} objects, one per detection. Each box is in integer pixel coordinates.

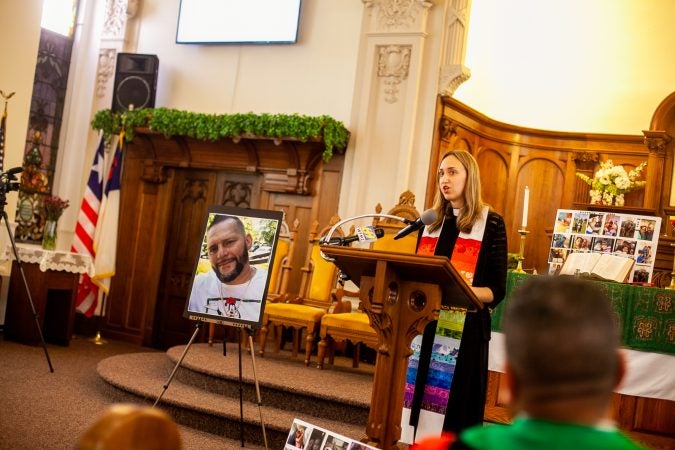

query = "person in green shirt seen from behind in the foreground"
[{"left": 411, "top": 276, "right": 643, "bottom": 450}]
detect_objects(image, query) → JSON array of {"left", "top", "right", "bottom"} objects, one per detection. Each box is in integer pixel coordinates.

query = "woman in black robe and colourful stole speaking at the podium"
[{"left": 404, "top": 150, "right": 507, "bottom": 438}]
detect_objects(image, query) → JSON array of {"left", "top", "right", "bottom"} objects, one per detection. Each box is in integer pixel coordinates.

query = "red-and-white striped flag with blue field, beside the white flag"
[{"left": 70, "top": 136, "right": 105, "bottom": 317}]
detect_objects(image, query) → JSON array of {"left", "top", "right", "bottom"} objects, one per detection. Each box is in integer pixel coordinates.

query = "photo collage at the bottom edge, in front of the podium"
[{"left": 284, "top": 419, "right": 377, "bottom": 450}]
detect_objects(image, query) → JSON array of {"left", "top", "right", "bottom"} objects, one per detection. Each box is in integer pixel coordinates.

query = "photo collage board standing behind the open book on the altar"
[{"left": 548, "top": 209, "right": 661, "bottom": 283}]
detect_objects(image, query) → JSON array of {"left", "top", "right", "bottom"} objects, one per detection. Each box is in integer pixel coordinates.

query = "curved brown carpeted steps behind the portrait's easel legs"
[{"left": 97, "top": 344, "right": 372, "bottom": 448}]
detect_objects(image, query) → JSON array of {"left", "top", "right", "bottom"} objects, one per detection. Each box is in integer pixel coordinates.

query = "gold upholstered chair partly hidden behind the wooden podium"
[{"left": 317, "top": 191, "right": 419, "bottom": 369}]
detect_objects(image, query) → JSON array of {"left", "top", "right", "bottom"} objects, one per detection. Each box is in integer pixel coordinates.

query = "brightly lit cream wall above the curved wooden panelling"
[{"left": 455, "top": 0, "right": 675, "bottom": 135}]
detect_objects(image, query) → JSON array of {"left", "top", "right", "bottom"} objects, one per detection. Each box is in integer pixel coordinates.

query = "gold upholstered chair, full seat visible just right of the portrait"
[{"left": 259, "top": 216, "right": 342, "bottom": 365}]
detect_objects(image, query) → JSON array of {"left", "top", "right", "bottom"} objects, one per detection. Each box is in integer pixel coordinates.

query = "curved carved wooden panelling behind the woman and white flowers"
[{"left": 426, "top": 97, "right": 672, "bottom": 273}]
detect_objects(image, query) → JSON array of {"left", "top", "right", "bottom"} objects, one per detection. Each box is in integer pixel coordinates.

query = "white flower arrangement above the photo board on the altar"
[{"left": 577, "top": 159, "right": 647, "bottom": 206}]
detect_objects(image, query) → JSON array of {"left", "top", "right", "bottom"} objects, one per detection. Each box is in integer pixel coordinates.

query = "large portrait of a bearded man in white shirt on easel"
[{"left": 184, "top": 205, "right": 283, "bottom": 329}]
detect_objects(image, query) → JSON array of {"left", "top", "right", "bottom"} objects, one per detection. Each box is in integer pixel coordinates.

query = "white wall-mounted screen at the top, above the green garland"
[{"left": 176, "top": 0, "right": 301, "bottom": 44}]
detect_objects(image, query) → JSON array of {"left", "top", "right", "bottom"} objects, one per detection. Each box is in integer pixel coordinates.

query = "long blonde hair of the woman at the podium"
[{"left": 429, "top": 150, "right": 487, "bottom": 233}]
